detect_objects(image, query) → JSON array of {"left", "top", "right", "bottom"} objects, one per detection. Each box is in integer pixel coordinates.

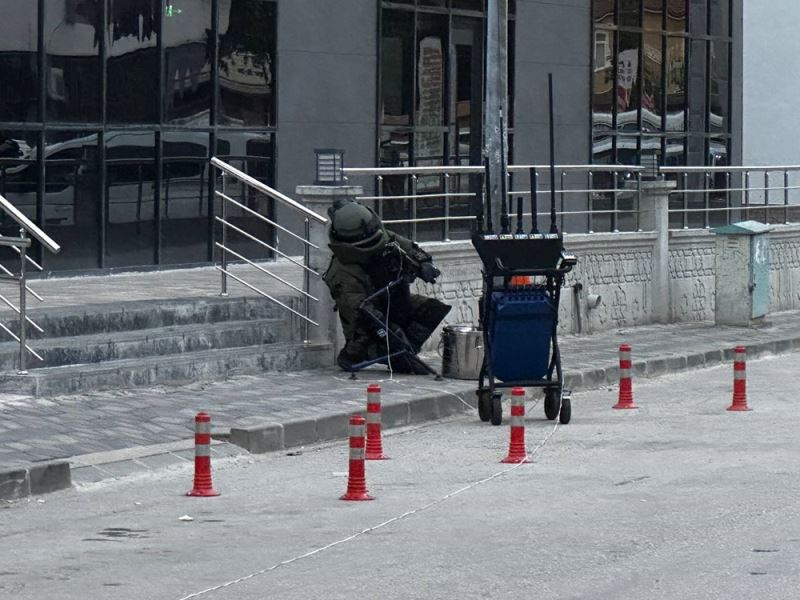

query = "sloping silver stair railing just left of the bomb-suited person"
[{"left": 211, "top": 157, "right": 328, "bottom": 342}]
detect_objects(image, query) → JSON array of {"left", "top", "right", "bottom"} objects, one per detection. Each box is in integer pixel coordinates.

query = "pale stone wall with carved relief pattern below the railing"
[{"left": 417, "top": 225, "right": 800, "bottom": 342}]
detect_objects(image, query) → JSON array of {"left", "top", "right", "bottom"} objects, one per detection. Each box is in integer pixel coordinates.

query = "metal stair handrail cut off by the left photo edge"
[{"left": 0, "top": 196, "right": 61, "bottom": 373}]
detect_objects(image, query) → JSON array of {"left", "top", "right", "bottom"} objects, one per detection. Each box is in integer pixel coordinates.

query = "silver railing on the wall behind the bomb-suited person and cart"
[{"left": 343, "top": 165, "right": 644, "bottom": 241}]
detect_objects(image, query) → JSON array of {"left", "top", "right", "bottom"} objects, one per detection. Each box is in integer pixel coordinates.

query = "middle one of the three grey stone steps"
[{"left": 0, "top": 319, "right": 291, "bottom": 371}]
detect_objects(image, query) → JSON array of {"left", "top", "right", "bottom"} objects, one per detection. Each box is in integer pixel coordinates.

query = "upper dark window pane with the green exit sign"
[{"left": 164, "top": 0, "right": 211, "bottom": 125}]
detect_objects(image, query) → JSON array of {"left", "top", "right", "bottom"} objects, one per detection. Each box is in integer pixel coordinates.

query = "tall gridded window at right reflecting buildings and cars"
[{"left": 592, "top": 0, "right": 731, "bottom": 165}]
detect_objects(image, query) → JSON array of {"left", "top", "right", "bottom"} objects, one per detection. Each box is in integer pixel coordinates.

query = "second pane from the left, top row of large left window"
[{"left": 44, "top": 0, "right": 103, "bottom": 123}]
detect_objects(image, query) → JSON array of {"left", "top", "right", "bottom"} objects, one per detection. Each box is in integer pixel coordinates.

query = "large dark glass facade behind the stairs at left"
[{"left": 0, "top": 0, "right": 277, "bottom": 270}]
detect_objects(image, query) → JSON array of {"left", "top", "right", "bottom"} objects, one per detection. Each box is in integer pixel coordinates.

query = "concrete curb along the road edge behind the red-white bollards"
[{"left": 0, "top": 337, "right": 800, "bottom": 501}]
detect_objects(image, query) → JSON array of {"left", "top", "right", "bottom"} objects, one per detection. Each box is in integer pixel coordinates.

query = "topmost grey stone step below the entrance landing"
[{"left": 0, "top": 296, "right": 300, "bottom": 340}]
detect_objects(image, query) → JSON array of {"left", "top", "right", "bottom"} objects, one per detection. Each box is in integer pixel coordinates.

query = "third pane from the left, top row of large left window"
[{"left": 106, "top": 0, "right": 161, "bottom": 123}]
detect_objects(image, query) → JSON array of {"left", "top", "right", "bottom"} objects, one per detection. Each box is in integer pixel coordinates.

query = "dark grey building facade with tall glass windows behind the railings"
[{"left": 0, "top": 0, "right": 742, "bottom": 271}]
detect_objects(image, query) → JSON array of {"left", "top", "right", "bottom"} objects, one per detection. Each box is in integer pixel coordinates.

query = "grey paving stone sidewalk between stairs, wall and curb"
[{"left": 0, "top": 312, "right": 800, "bottom": 492}]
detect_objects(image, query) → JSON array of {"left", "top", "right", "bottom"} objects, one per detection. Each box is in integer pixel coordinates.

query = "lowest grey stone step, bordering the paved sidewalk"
[{"left": 0, "top": 343, "right": 333, "bottom": 396}]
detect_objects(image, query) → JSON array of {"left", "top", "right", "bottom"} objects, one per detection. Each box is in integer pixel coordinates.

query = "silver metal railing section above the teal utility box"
[{"left": 659, "top": 165, "right": 800, "bottom": 229}]
